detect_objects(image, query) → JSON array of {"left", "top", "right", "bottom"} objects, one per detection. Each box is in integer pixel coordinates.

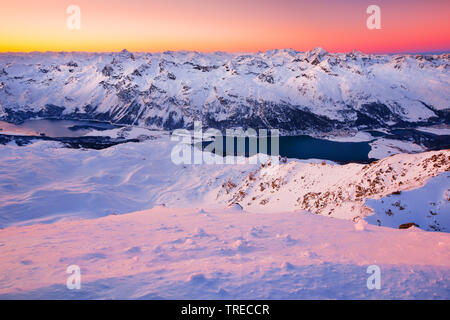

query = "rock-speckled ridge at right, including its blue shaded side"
[{"left": 216, "top": 150, "right": 450, "bottom": 232}]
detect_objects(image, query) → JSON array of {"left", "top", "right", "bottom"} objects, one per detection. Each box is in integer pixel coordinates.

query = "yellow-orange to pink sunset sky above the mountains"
[{"left": 0, "top": 0, "right": 450, "bottom": 52}]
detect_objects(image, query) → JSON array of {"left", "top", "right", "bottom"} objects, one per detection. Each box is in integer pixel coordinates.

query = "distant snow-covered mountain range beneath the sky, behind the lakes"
[{"left": 0, "top": 48, "right": 450, "bottom": 134}]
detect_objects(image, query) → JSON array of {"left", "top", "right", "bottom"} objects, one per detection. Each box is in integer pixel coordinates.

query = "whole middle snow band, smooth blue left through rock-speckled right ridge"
[{"left": 0, "top": 134, "right": 450, "bottom": 230}]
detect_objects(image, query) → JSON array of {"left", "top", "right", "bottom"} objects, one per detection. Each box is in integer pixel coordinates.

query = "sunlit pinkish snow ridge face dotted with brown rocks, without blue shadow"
[{"left": 216, "top": 150, "right": 450, "bottom": 222}]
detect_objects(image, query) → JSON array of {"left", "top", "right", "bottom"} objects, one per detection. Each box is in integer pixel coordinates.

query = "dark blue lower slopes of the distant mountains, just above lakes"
[{"left": 0, "top": 100, "right": 450, "bottom": 139}]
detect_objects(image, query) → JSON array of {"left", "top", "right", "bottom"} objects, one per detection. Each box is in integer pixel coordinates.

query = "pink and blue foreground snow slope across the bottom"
[{"left": 0, "top": 207, "right": 450, "bottom": 299}]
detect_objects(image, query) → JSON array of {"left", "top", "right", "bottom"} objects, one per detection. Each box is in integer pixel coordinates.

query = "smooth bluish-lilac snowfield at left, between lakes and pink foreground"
[{"left": 0, "top": 136, "right": 256, "bottom": 227}]
